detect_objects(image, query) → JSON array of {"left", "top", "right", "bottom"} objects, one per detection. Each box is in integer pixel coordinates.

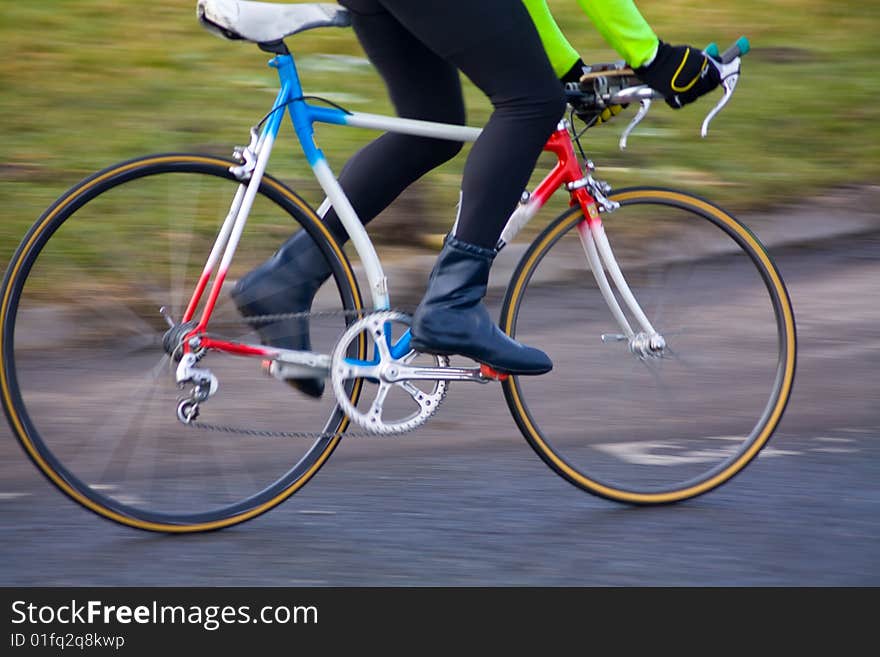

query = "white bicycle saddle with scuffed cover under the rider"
[{"left": 196, "top": 0, "right": 351, "bottom": 43}]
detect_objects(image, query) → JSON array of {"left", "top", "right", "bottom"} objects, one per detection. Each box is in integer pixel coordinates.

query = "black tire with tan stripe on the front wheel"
[{"left": 500, "top": 187, "right": 797, "bottom": 505}]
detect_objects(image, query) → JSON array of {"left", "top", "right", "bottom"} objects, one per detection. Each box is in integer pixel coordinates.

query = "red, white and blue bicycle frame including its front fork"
[{"left": 180, "top": 54, "right": 656, "bottom": 372}]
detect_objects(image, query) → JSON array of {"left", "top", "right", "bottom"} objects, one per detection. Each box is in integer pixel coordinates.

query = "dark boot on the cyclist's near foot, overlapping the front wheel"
[{"left": 411, "top": 235, "right": 553, "bottom": 375}]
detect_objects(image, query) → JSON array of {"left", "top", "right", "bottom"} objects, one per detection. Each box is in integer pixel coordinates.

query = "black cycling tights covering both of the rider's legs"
[{"left": 325, "top": 0, "right": 565, "bottom": 248}]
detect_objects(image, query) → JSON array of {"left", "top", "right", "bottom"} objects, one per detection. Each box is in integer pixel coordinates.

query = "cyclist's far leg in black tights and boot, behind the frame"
[{"left": 232, "top": 3, "right": 465, "bottom": 397}]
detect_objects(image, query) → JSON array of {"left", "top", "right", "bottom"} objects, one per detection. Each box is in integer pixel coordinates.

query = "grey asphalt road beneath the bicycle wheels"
[{"left": 0, "top": 229, "right": 880, "bottom": 586}]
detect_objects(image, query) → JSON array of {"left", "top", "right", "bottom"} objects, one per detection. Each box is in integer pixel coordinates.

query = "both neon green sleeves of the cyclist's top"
[{"left": 522, "top": 0, "right": 659, "bottom": 72}]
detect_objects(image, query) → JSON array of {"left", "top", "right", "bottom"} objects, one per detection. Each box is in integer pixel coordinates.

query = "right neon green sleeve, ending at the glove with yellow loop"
[{"left": 578, "top": 0, "right": 659, "bottom": 67}]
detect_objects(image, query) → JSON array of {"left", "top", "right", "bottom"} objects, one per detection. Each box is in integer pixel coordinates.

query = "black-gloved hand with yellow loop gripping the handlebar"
[{"left": 633, "top": 41, "right": 721, "bottom": 109}]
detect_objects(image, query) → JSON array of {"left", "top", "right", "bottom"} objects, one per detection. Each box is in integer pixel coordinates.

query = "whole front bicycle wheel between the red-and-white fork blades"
[{"left": 501, "top": 188, "right": 796, "bottom": 504}]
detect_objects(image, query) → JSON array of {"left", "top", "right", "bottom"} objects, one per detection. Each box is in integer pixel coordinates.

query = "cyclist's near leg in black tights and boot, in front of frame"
[{"left": 379, "top": 0, "right": 565, "bottom": 374}]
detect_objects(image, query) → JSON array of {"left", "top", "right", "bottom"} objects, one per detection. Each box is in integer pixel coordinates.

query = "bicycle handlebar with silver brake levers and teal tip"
[{"left": 578, "top": 37, "right": 751, "bottom": 150}]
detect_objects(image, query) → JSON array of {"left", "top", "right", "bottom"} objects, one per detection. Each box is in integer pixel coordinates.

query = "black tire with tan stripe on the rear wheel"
[{"left": 0, "top": 153, "right": 363, "bottom": 533}]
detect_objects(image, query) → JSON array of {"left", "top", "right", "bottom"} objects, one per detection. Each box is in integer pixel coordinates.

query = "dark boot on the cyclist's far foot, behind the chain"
[{"left": 232, "top": 230, "right": 331, "bottom": 398}]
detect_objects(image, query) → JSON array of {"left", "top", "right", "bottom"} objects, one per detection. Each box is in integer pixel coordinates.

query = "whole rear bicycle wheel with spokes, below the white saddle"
[{"left": 0, "top": 154, "right": 365, "bottom": 532}]
